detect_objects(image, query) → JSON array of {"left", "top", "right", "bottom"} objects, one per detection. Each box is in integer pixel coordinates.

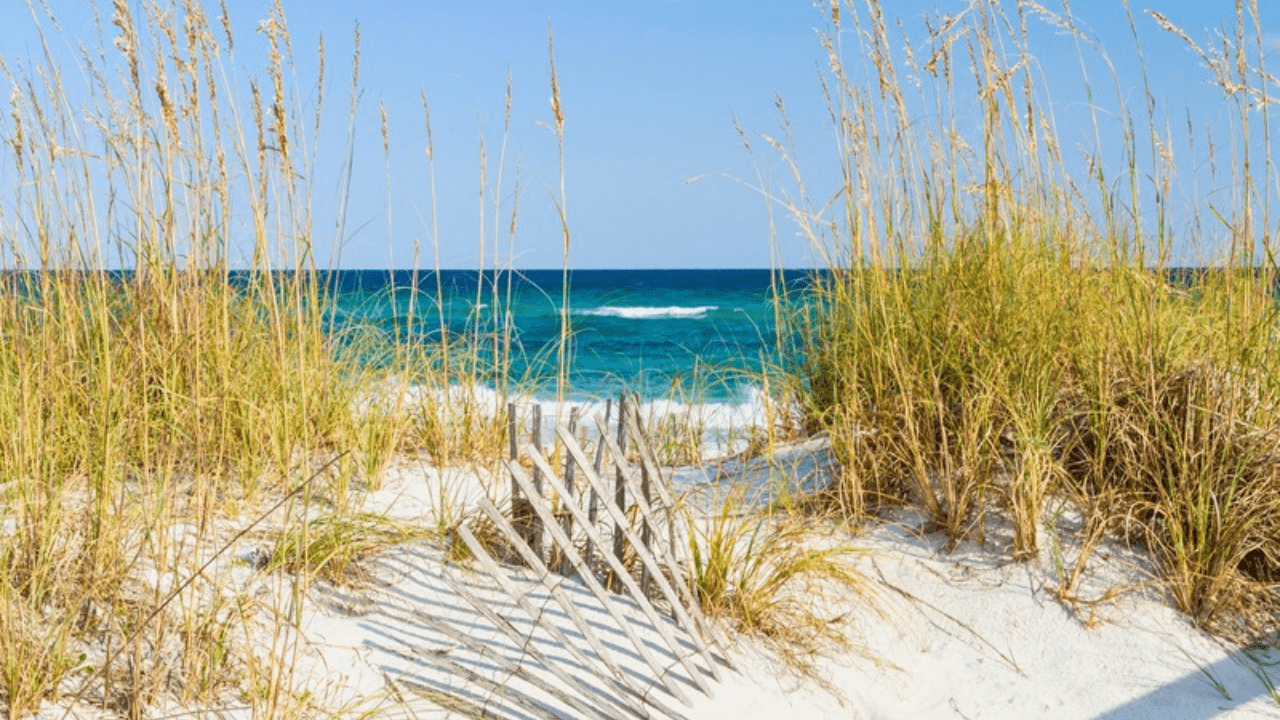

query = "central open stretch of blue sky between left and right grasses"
[{"left": 285, "top": 0, "right": 824, "bottom": 268}]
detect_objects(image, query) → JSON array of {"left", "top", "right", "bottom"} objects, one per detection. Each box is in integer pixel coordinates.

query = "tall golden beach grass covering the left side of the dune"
[{"left": 0, "top": 0, "right": 515, "bottom": 717}]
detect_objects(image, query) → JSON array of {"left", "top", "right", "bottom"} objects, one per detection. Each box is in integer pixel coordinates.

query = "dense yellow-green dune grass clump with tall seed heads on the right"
[{"left": 771, "top": 0, "right": 1280, "bottom": 637}]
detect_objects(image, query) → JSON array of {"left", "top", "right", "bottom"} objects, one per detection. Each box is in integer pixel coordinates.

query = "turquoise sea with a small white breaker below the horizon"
[{"left": 320, "top": 270, "right": 805, "bottom": 402}]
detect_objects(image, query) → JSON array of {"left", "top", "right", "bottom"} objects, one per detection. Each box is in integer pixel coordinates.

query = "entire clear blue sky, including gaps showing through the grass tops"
[{"left": 0, "top": 0, "right": 1280, "bottom": 268}]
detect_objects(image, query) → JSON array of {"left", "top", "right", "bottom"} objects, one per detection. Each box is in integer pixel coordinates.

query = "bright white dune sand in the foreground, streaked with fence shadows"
[{"left": 45, "top": 448, "right": 1280, "bottom": 720}]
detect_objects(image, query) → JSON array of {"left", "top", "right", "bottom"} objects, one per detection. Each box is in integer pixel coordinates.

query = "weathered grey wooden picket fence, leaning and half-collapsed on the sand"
[{"left": 430, "top": 397, "right": 732, "bottom": 720}]
